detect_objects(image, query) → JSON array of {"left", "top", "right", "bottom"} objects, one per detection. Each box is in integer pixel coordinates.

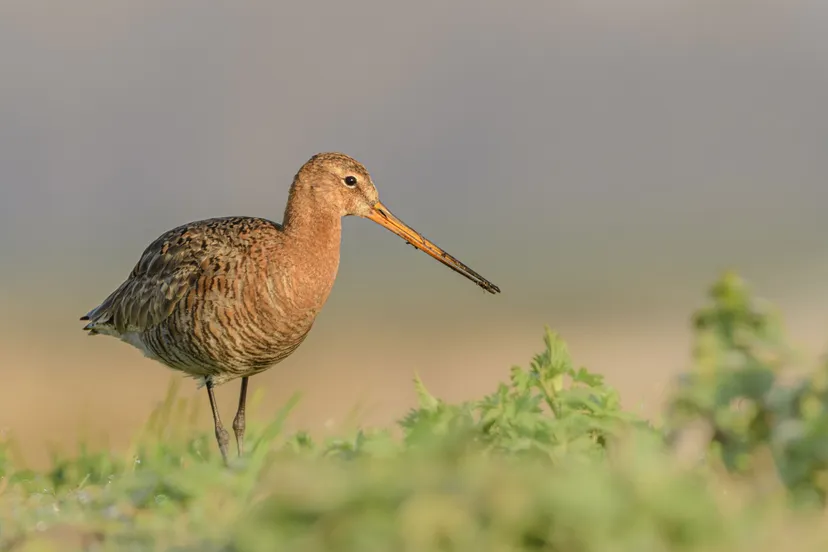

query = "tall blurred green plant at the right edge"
[{"left": 666, "top": 273, "right": 828, "bottom": 504}]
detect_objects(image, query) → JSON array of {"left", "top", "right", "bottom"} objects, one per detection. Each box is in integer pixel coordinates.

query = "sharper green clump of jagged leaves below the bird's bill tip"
[{"left": 400, "top": 329, "right": 648, "bottom": 462}]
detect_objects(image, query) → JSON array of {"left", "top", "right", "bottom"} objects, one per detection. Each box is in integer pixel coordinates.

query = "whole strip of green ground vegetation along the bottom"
[{"left": 0, "top": 274, "right": 828, "bottom": 552}]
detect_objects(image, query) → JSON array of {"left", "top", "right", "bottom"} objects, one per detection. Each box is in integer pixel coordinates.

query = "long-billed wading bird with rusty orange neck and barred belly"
[{"left": 80, "top": 152, "right": 500, "bottom": 465}]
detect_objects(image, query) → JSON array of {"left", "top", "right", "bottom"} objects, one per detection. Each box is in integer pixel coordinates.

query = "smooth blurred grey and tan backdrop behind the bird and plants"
[{"left": 0, "top": 0, "right": 828, "bottom": 463}]
